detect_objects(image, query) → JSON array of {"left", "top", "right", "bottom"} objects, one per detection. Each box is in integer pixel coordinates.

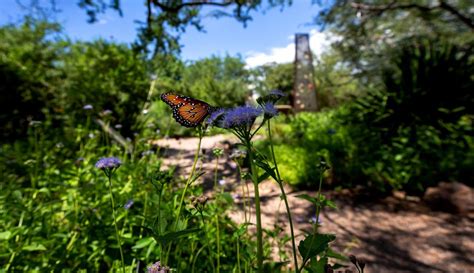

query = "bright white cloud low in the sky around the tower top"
[{"left": 245, "top": 29, "right": 331, "bottom": 68}]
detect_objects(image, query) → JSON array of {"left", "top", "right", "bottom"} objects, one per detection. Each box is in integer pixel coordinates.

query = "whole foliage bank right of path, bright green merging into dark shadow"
[{"left": 260, "top": 38, "right": 474, "bottom": 193}]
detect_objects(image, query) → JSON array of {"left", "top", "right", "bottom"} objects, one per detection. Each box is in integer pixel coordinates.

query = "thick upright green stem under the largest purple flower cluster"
[{"left": 246, "top": 141, "right": 263, "bottom": 273}]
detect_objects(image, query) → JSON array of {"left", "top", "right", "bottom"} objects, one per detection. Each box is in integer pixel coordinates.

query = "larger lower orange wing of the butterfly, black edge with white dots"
[{"left": 173, "top": 100, "right": 210, "bottom": 127}]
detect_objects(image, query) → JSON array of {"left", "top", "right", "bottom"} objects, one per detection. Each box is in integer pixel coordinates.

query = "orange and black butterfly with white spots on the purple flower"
[{"left": 161, "top": 92, "right": 216, "bottom": 127}]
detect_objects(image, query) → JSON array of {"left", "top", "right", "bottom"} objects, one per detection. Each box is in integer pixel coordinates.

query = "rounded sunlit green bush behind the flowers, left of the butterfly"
[{"left": 61, "top": 40, "right": 150, "bottom": 136}]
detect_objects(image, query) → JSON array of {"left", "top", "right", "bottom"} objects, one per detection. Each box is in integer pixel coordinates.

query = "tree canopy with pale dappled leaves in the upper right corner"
[{"left": 315, "top": 0, "right": 474, "bottom": 75}]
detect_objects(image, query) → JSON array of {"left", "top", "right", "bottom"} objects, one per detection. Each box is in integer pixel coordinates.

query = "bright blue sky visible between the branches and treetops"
[{"left": 0, "top": 0, "right": 327, "bottom": 66}]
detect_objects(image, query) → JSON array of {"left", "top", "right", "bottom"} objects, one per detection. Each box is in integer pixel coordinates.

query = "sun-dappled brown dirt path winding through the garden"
[{"left": 157, "top": 135, "right": 474, "bottom": 273}]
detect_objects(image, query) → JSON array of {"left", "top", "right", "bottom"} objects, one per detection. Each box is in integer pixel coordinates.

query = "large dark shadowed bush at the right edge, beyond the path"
[{"left": 343, "top": 38, "right": 474, "bottom": 193}]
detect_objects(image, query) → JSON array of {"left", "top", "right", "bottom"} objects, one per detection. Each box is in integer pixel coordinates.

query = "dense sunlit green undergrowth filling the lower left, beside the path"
[{"left": 0, "top": 118, "right": 243, "bottom": 272}]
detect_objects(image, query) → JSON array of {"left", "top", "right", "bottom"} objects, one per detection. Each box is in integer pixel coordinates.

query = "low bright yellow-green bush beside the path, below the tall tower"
[{"left": 260, "top": 107, "right": 361, "bottom": 188}]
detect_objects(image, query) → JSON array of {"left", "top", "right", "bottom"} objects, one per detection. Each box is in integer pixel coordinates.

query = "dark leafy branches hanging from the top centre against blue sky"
[{"left": 79, "top": 0, "right": 291, "bottom": 55}]
